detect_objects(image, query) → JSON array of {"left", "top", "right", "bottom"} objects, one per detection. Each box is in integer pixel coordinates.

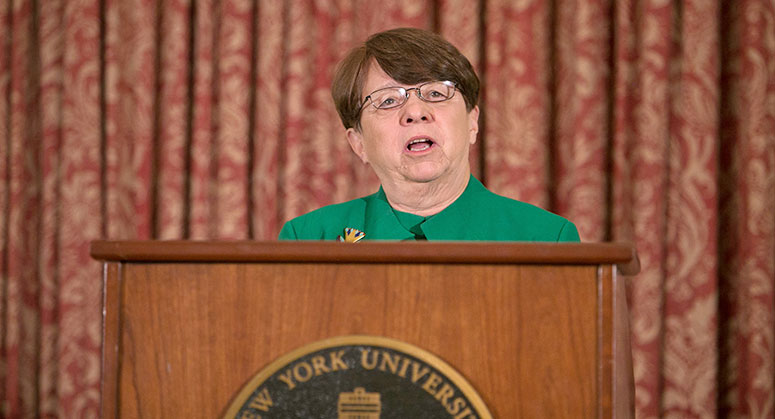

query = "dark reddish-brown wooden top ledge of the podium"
[{"left": 90, "top": 240, "right": 640, "bottom": 275}]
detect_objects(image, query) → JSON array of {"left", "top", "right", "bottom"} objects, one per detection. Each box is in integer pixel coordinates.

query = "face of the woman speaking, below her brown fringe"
[{"left": 347, "top": 62, "right": 479, "bottom": 186}]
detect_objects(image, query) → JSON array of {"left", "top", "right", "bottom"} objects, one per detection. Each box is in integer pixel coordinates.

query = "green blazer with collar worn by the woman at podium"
[{"left": 279, "top": 176, "right": 579, "bottom": 242}]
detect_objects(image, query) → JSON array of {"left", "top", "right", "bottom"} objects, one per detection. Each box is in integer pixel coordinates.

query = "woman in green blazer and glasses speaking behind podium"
[{"left": 280, "top": 28, "right": 579, "bottom": 242}]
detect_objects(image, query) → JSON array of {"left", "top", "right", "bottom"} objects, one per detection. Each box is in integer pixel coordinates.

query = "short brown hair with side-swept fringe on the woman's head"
[{"left": 331, "top": 28, "right": 479, "bottom": 129}]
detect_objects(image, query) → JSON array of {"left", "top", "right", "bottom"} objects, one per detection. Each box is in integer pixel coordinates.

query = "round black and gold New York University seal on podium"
[{"left": 224, "top": 335, "right": 492, "bottom": 419}]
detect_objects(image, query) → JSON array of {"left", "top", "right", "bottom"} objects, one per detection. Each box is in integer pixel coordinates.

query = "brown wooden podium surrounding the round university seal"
[{"left": 91, "top": 241, "right": 638, "bottom": 419}]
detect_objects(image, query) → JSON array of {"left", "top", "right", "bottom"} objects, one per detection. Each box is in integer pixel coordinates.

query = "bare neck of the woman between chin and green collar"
[{"left": 382, "top": 171, "right": 471, "bottom": 217}]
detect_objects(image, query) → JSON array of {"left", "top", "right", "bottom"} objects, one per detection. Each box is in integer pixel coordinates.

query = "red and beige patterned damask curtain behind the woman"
[{"left": 0, "top": 0, "right": 775, "bottom": 418}]
